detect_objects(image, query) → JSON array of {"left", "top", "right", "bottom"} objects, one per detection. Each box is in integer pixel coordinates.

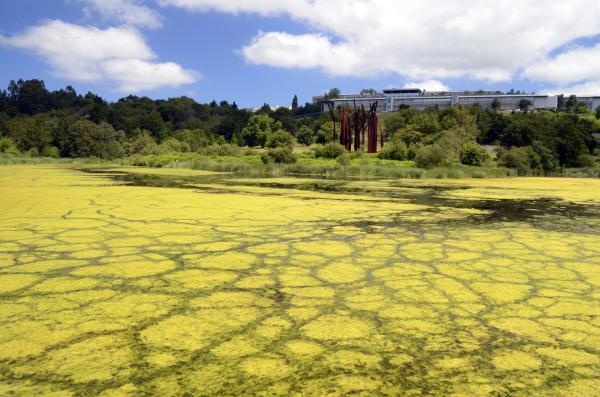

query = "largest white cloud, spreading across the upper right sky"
[{"left": 157, "top": 0, "right": 600, "bottom": 87}]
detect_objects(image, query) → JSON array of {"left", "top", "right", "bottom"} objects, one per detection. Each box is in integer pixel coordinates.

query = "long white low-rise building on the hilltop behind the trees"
[{"left": 313, "top": 88, "right": 600, "bottom": 112}]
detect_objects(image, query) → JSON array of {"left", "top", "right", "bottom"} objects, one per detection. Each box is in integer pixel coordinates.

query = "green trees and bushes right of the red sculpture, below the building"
[{"left": 380, "top": 103, "right": 600, "bottom": 174}]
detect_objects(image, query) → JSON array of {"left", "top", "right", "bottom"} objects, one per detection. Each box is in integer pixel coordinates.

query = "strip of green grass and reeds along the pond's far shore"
[{"left": 0, "top": 153, "right": 600, "bottom": 179}]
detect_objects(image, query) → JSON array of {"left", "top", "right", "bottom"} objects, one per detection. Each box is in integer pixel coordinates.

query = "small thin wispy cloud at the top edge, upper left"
[{"left": 79, "top": 0, "right": 162, "bottom": 29}]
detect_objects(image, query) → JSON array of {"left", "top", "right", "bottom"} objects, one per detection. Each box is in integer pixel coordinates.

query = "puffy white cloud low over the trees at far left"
[{"left": 0, "top": 20, "right": 199, "bottom": 92}]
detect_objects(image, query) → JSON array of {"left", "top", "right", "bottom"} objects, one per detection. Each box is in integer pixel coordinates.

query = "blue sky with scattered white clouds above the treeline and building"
[{"left": 0, "top": 0, "right": 600, "bottom": 107}]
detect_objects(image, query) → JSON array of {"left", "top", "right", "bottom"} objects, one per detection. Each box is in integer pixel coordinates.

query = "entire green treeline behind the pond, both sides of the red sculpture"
[{"left": 0, "top": 80, "right": 600, "bottom": 174}]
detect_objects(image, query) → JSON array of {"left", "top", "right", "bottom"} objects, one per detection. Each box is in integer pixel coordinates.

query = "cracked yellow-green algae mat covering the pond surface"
[{"left": 0, "top": 166, "right": 600, "bottom": 397}]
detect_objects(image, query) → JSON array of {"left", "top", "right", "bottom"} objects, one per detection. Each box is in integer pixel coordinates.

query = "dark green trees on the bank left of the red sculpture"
[{"left": 0, "top": 79, "right": 320, "bottom": 158}]
